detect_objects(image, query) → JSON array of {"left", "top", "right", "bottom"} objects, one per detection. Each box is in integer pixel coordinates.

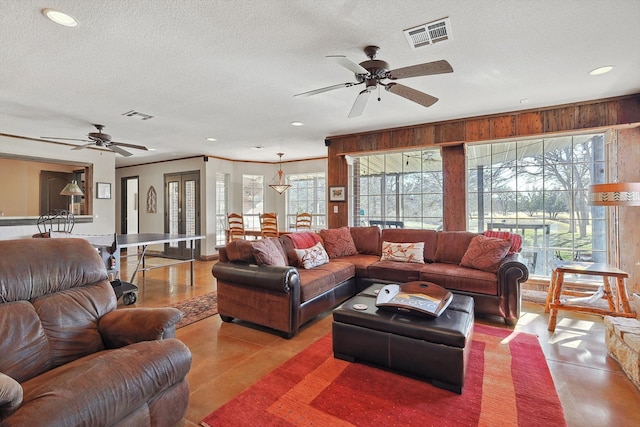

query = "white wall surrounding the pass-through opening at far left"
[{"left": 0, "top": 135, "right": 116, "bottom": 240}]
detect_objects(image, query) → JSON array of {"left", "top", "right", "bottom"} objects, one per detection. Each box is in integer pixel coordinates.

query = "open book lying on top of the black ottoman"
[{"left": 376, "top": 282, "right": 453, "bottom": 317}]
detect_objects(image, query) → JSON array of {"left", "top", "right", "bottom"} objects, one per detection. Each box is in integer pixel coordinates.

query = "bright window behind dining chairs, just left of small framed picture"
[{"left": 286, "top": 172, "right": 327, "bottom": 229}]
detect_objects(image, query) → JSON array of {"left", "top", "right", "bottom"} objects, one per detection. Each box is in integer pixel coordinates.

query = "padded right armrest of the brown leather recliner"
[{"left": 98, "top": 307, "right": 182, "bottom": 348}]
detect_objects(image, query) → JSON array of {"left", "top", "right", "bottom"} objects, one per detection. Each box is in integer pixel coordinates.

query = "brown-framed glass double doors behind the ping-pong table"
[{"left": 164, "top": 171, "right": 200, "bottom": 258}]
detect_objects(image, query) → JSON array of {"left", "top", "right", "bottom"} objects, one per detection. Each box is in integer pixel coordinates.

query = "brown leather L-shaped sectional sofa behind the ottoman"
[{"left": 212, "top": 227, "right": 529, "bottom": 338}]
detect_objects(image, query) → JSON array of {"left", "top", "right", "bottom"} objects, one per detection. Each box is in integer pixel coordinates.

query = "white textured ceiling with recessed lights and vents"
[{"left": 0, "top": 0, "right": 640, "bottom": 166}]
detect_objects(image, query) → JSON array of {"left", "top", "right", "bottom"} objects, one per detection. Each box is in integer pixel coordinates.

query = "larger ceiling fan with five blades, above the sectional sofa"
[{"left": 294, "top": 46, "right": 453, "bottom": 117}]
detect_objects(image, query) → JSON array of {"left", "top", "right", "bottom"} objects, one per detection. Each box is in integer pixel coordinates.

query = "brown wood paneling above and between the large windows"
[{"left": 327, "top": 94, "right": 640, "bottom": 230}]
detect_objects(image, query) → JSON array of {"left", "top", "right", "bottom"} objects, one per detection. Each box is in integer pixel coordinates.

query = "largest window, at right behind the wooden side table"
[{"left": 467, "top": 134, "right": 607, "bottom": 276}]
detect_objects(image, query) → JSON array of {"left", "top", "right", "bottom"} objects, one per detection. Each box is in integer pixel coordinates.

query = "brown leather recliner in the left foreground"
[{"left": 0, "top": 238, "right": 191, "bottom": 426}]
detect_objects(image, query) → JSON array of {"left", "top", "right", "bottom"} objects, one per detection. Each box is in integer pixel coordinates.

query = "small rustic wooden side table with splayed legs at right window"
[{"left": 544, "top": 261, "right": 636, "bottom": 332}]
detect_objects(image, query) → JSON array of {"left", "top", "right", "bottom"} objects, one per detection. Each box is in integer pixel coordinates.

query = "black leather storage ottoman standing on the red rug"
[{"left": 333, "top": 284, "right": 474, "bottom": 394}]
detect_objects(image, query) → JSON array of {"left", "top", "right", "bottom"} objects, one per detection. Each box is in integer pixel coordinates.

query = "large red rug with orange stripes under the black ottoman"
[{"left": 201, "top": 325, "right": 566, "bottom": 426}]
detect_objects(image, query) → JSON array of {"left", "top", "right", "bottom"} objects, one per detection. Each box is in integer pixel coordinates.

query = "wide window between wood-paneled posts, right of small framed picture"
[{"left": 350, "top": 149, "right": 442, "bottom": 230}]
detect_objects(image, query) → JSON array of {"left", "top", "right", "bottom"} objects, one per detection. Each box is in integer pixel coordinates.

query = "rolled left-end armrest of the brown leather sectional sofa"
[{"left": 211, "top": 262, "right": 300, "bottom": 294}]
